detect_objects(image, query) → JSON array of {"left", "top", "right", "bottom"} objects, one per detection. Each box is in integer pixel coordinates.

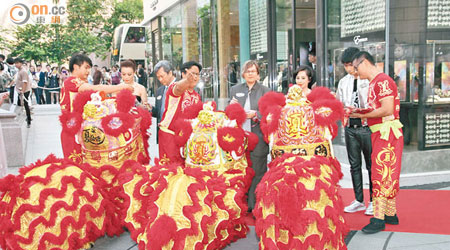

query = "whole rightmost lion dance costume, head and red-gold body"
[{"left": 253, "top": 85, "right": 348, "bottom": 250}]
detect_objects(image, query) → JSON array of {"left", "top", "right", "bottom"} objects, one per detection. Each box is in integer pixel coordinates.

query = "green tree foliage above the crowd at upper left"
[{"left": 5, "top": 0, "right": 143, "bottom": 64}]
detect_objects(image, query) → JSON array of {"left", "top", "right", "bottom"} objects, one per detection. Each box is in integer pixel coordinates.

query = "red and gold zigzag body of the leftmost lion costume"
[{"left": 0, "top": 155, "right": 122, "bottom": 250}]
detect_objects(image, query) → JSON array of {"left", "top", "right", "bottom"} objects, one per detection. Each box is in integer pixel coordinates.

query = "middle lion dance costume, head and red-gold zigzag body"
[{"left": 119, "top": 104, "right": 253, "bottom": 249}]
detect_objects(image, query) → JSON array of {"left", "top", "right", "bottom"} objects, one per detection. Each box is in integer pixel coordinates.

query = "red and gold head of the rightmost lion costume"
[{"left": 259, "top": 85, "right": 343, "bottom": 158}]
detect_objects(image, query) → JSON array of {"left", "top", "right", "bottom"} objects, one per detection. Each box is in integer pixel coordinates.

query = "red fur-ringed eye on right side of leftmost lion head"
[{"left": 102, "top": 112, "right": 135, "bottom": 137}]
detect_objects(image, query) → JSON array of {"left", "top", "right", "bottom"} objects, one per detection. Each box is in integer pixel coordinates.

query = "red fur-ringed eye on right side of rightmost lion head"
[{"left": 311, "top": 98, "right": 344, "bottom": 127}]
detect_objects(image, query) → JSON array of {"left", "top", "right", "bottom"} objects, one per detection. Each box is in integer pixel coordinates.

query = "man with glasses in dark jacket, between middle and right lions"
[{"left": 230, "top": 61, "right": 270, "bottom": 211}]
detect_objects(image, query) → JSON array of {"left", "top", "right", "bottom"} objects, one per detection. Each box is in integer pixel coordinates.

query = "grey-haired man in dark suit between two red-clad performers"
[{"left": 152, "top": 60, "right": 176, "bottom": 142}]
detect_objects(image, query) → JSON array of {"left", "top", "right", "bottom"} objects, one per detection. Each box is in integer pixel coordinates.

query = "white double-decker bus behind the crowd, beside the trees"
[{"left": 111, "top": 24, "right": 147, "bottom": 67}]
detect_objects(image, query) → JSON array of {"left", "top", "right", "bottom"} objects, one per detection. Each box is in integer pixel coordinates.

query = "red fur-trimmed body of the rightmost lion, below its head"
[{"left": 253, "top": 154, "right": 348, "bottom": 249}]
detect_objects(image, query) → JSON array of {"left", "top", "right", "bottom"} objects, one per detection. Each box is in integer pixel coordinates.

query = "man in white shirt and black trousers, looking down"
[{"left": 336, "top": 47, "right": 373, "bottom": 215}]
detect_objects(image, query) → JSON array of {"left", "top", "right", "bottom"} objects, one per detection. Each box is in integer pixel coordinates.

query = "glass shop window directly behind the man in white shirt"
[{"left": 326, "top": 0, "right": 386, "bottom": 90}]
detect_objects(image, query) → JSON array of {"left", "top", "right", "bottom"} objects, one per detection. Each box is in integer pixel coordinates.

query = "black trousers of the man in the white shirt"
[{"left": 345, "top": 127, "right": 372, "bottom": 202}]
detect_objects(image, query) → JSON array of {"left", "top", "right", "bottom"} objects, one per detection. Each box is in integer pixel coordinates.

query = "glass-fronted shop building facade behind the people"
[{"left": 143, "top": 0, "right": 450, "bottom": 150}]
